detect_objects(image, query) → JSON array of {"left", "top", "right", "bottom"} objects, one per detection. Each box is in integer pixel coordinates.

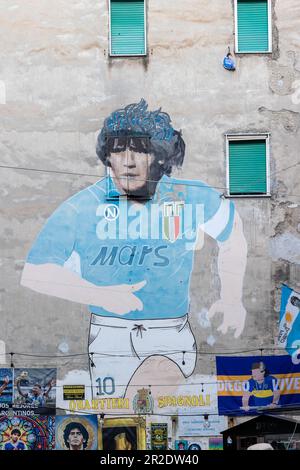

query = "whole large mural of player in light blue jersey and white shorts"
[{"left": 21, "top": 99, "right": 247, "bottom": 397}]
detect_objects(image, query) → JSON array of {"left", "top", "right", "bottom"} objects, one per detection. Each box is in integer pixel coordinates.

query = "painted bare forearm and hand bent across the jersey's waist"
[{"left": 21, "top": 263, "right": 146, "bottom": 315}]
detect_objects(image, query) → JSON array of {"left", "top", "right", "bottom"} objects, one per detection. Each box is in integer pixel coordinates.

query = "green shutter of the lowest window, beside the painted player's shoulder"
[{"left": 229, "top": 140, "right": 267, "bottom": 195}]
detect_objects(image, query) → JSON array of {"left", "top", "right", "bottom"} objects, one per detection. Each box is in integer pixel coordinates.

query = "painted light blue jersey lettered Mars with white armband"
[{"left": 27, "top": 176, "right": 234, "bottom": 320}]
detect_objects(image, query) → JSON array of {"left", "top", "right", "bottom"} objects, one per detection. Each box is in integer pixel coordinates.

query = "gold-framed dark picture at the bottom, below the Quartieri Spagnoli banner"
[{"left": 99, "top": 418, "right": 146, "bottom": 450}]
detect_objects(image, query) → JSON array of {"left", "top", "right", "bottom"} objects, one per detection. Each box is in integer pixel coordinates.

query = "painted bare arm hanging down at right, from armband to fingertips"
[{"left": 208, "top": 212, "right": 247, "bottom": 338}]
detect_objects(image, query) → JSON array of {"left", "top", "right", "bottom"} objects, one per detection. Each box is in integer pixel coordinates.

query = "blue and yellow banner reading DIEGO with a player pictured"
[{"left": 216, "top": 355, "right": 300, "bottom": 416}]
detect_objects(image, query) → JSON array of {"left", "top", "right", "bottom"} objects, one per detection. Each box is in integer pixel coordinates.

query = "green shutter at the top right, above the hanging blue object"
[{"left": 237, "top": 0, "right": 270, "bottom": 52}]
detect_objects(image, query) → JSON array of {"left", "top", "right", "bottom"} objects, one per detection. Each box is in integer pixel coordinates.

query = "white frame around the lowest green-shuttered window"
[{"left": 225, "top": 132, "right": 271, "bottom": 198}]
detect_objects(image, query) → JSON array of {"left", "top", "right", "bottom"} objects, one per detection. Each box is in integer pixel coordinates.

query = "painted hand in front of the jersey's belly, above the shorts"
[{"left": 95, "top": 281, "right": 146, "bottom": 315}]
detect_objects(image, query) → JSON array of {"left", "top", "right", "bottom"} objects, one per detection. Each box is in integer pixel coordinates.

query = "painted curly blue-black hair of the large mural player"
[{"left": 96, "top": 99, "right": 185, "bottom": 176}]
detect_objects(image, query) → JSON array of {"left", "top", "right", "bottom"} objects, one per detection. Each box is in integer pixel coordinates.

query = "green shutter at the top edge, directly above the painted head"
[{"left": 110, "top": 0, "right": 146, "bottom": 55}]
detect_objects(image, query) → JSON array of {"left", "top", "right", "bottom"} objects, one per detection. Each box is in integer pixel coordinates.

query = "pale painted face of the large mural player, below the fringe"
[{"left": 110, "top": 148, "right": 154, "bottom": 197}]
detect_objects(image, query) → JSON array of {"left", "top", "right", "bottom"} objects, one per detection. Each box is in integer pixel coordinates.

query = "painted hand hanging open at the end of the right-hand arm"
[{"left": 208, "top": 299, "right": 247, "bottom": 338}]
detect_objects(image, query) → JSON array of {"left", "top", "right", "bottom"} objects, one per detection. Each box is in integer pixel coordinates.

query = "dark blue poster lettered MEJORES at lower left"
[{"left": 13, "top": 368, "right": 56, "bottom": 415}]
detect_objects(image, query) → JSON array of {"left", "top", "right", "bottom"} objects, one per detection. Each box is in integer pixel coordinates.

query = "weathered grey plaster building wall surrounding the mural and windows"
[{"left": 0, "top": 0, "right": 300, "bottom": 436}]
